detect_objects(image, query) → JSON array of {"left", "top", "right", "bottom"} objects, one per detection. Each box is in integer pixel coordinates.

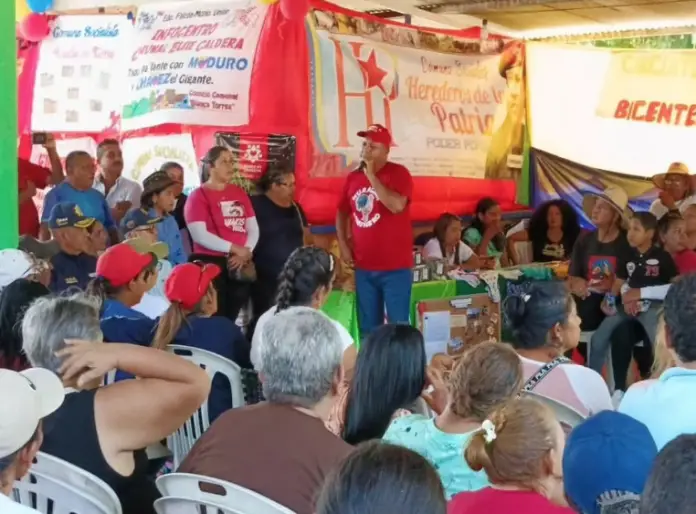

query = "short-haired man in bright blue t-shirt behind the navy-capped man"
[{"left": 40, "top": 151, "right": 119, "bottom": 244}]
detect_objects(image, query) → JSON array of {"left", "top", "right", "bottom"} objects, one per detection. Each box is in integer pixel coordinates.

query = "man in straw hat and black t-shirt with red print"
[{"left": 569, "top": 186, "right": 632, "bottom": 331}]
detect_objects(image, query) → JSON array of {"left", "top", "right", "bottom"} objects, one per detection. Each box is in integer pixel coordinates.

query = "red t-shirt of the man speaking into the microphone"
[{"left": 338, "top": 162, "right": 413, "bottom": 271}]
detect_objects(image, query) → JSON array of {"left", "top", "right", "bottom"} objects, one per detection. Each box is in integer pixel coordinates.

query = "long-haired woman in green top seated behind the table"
[{"left": 462, "top": 197, "right": 510, "bottom": 268}]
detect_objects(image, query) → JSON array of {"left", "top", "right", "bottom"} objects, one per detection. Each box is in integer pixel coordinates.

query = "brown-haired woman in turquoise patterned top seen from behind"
[{"left": 383, "top": 343, "right": 523, "bottom": 499}]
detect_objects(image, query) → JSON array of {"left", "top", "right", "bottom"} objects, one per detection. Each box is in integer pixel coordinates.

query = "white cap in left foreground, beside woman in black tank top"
[{"left": 0, "top": 368, "right": 65, "bottom": 458}]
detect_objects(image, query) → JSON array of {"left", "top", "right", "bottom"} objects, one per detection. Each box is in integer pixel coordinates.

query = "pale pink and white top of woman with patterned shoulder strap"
[{"left": 520, "top": 355, "right": 614, "bottom": 416}]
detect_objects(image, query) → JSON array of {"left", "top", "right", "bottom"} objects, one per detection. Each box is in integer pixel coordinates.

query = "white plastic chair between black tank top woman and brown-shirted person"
[{"left": 167, "top": 344, "right": 244, "bottom": 469}]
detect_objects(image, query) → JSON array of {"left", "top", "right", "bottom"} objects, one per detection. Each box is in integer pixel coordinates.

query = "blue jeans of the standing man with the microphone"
[{"left": 355, "top": 268, "right": 413, "bottom": 338}]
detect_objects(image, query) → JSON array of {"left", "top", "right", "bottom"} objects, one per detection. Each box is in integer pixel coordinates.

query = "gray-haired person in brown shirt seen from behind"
[{"left": 178, "top": 307, "right": 351, "bottom": 514}]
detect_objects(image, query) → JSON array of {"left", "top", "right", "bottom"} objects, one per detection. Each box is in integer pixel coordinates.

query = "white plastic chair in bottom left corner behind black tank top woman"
[{"left": 12, "top": 469, "right": 121, "bottom": 514}]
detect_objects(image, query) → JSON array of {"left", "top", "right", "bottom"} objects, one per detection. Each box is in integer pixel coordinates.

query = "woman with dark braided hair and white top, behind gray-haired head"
[{"left": 251, "top": 246, "right": 357, "bottom": 375}]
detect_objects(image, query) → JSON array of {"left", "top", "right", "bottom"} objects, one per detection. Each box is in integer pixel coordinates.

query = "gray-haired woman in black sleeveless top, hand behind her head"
[{"left": 22, "top": 295, "right": 210, "bottom": 514}]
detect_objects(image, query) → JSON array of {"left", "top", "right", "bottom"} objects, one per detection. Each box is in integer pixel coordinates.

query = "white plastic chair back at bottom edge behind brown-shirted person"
[{"left": 157, "top": 473, "right": 294, "bottom": 514}]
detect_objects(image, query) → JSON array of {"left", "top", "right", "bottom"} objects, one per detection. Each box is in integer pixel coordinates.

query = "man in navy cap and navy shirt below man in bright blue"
[{"left": 48, "top": 202, "right": 97, "bottom": 293}]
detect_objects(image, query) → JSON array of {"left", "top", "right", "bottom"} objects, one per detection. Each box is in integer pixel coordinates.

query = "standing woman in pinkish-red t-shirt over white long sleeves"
[{"left": 184, "top": 146, "right": 259, "bottom": 321}]
